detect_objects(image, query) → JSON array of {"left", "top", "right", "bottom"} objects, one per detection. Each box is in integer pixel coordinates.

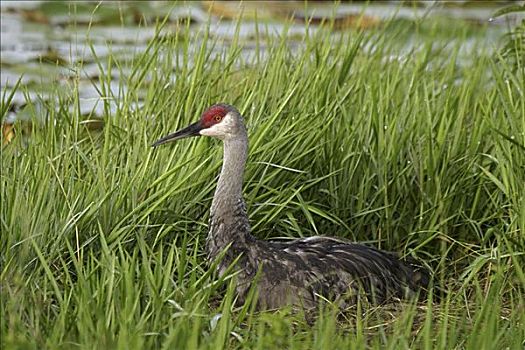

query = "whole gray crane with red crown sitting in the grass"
[{"left": 154, "top": 104, "right": 429, "bottom": 309}]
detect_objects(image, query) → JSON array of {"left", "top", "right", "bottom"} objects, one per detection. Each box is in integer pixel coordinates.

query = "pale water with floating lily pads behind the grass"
[{"left": 0, "top": 1, "right": 519, "bottom": 127}]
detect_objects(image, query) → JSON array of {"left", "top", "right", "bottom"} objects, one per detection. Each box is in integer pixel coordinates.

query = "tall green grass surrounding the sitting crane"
[{"left": 0, "top": 13, "right": 525, "bottom": 350}]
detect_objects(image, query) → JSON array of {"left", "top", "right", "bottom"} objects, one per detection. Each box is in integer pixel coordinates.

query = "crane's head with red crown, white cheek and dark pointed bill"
[{"left": 152, "top": 103, "right": 246, "bottom": 147}]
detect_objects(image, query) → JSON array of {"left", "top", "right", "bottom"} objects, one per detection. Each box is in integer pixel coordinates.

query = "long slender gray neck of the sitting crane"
[{"left": 206, "top": 132, "right": 251, "bottom": 258}]
